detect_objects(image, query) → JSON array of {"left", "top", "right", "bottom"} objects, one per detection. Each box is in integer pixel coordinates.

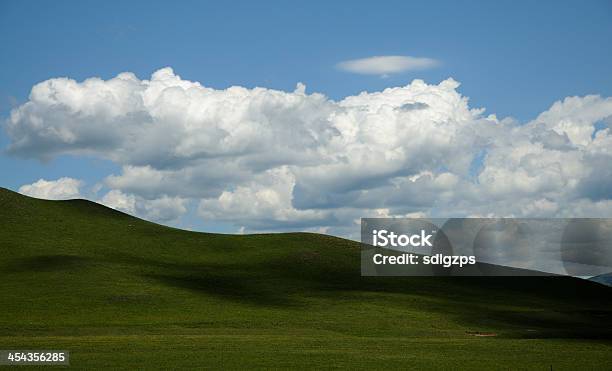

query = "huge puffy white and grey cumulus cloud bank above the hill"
[{"left": 5, "top": 68, "right": 612, "bottom": 235}]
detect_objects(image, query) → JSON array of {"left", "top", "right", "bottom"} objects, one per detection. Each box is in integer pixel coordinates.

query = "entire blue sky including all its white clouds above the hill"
[{"left": 0, "top": 0, "right": 612, "bottom": 236}]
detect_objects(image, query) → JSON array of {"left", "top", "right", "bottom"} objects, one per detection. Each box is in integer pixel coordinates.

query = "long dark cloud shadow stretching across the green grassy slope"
[{"left": 9, "top": 249, "right": 612, "bottom": 339}]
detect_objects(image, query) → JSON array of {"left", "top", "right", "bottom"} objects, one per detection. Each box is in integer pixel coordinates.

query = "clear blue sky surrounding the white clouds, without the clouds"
[{"left": 0, "top": 0, "right": 612, "bottom": 237}]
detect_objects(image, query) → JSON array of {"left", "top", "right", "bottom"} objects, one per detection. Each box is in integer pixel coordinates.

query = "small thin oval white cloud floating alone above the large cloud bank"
[{"left": 337, "top": 55, "right": 439, "bottom": 76}]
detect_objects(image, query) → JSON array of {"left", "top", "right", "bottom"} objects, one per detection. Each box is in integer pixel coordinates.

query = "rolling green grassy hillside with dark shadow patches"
[{"left": 0, "top": 189, "right": 612, "bottom": 370}]
